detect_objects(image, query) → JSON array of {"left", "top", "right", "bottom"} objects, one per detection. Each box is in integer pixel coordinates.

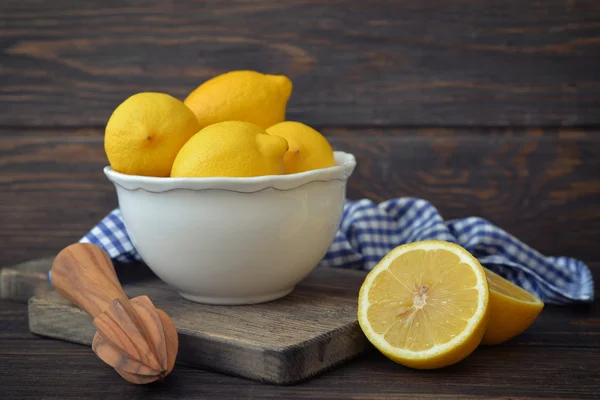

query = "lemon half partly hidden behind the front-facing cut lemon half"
[{"left": 481, "top": 269, "right": 544, "bottom": 345}]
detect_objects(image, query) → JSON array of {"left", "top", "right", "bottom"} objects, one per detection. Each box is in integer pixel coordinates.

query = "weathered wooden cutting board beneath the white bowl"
[{"left": 11, "top": 258, "right": 370, "bottom": 384}]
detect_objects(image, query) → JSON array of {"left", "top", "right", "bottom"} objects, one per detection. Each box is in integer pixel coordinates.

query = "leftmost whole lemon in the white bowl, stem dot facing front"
[{"left": 104, "top": 92, "right": 200, "bottom": 177}]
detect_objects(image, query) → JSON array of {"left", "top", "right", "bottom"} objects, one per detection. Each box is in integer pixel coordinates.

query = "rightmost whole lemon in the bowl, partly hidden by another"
[{"left": 267, "top": 121, "right": 335, "bottom": 174}]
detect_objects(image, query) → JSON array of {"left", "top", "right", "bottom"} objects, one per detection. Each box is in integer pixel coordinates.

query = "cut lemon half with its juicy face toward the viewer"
[{"left": 358, "top": 240, "right": 488, "bottom": 369}]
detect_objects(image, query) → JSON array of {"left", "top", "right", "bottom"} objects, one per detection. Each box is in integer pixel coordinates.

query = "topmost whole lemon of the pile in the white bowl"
[{"left": 184, "top": 71, "right": 292, "bottom": 128}]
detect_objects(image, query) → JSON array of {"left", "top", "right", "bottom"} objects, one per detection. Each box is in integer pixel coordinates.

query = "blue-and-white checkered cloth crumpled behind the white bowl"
[{"left": 80, "top": 198, "right": 594, "bottom": 304}]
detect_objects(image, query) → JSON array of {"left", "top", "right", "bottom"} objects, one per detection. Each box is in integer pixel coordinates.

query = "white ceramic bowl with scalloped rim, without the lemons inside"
[{"left": 104, "top": 152, "right": 356, "bottom": 304}]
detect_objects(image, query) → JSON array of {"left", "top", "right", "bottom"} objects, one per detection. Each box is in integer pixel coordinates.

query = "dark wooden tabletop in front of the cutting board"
[{"left": 0, "top": 263, "right": 600, "bottom": 400}]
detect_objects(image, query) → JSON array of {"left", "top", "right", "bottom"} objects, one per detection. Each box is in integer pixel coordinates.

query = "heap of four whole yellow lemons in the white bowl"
[{"left": 104, "top": 70, "right": 335, "bottom": 177}]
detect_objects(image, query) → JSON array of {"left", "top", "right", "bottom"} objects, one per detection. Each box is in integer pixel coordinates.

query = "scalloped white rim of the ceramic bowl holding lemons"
[{"left": 104, "top": 151, "right": 356, "bottom": 193}]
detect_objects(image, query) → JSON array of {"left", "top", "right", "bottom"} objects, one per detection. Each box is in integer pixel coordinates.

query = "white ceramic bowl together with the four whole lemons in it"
[{"left": 104, "top": 71, "right": 356, "bottom": 304}]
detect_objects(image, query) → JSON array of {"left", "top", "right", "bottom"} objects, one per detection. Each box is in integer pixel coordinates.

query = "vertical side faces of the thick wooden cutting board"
[{"left": 28, "top": 292, "right": 368, "bottom": 385}]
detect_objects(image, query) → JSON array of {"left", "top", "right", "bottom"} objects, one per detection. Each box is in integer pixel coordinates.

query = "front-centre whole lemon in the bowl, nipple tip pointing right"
[{"left": 171, "top": 121, "right": 288, "bottom": 177}]
